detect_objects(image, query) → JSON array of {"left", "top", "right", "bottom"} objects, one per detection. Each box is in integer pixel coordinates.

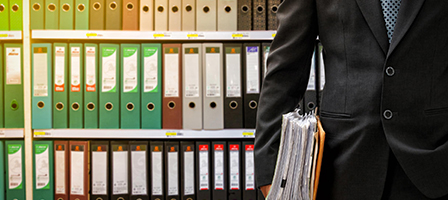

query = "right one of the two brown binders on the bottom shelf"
[{"left": 69, "top": 141, "right": 89, "bottom": 200}]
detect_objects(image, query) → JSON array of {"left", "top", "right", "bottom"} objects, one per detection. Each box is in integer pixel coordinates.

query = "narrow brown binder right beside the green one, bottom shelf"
[{"left": 54, "top": 141, "right": 70, "bottom": 200}]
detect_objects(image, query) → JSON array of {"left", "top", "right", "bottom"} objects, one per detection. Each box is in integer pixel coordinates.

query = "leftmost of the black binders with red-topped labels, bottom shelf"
[{"left": 195, "top": 141, "right": 212, "bottom": 200}]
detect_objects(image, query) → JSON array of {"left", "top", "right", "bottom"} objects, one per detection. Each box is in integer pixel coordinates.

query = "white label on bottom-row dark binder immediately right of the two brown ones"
[{"left": 92, "top": 151, "right": 107, "bottom": 195}]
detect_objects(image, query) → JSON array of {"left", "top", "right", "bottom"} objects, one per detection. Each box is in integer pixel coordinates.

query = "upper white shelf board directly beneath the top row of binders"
[{"left": 31, "top": 30, "right": 276, "bottom": 41}]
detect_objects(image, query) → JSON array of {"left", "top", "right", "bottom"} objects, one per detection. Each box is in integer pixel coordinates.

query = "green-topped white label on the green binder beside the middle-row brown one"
[{"left": 143, "top": 47, "right": 159, "bottom": 93}]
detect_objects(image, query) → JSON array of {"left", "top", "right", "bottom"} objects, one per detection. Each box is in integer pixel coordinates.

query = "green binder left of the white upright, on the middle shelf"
[{"left": 3, "top": 43, "right": 24, "bottom": 128}]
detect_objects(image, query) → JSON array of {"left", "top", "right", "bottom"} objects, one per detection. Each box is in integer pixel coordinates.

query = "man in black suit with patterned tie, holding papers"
[{"left": 255, "top": 0, "right": 448, "bottom": 200}]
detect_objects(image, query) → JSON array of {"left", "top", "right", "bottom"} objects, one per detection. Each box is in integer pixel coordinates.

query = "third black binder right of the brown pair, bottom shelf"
[{"left": 129, "top": 141, "right": 150, "bottom": 200}]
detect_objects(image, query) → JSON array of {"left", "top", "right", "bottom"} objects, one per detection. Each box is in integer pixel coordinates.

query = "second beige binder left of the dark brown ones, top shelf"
[{"left": 196, "top": 0, "right": 216, "bottom": 31}]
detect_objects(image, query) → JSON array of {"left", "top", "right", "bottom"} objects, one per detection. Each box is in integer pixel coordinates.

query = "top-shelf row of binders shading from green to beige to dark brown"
[{"left": 29, "top": 0, "right": 280, "bottom": 31}]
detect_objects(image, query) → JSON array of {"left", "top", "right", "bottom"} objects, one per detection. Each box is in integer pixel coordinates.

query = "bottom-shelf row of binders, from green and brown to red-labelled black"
[{"left": 28, "top": 141, "right": 264, "bottom": 200}]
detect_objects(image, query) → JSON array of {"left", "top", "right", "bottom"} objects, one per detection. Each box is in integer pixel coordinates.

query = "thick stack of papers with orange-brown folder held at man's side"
[{"left": 267, "top": 110, "right": 325, "bottom": 200}]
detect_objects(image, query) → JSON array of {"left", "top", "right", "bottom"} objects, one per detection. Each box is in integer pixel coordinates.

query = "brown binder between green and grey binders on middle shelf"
[{"left": 162, "top": 44, "right": 182, "bottom": 129}]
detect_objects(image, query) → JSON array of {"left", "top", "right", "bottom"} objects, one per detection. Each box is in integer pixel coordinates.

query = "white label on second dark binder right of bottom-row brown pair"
[{"left": 112, "top": 151, "right": 128, "bottom": 194}]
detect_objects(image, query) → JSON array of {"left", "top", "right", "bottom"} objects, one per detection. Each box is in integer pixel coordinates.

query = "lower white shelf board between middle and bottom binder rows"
[{"left": 34, "top": 129, "right": 255, "bottom": 139}]
